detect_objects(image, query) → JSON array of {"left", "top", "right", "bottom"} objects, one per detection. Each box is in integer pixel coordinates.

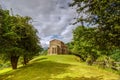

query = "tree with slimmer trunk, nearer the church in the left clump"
[{"left": 15, "top": 16, "right": 41, "bottom": 65}]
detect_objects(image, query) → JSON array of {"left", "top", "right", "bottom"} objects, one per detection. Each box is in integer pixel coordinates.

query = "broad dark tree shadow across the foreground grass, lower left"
[{"left": 1, "top": 61, "right": 71, "bottom": 80}]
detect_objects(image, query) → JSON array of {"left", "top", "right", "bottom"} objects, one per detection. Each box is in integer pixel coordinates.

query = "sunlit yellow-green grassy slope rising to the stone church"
[{"left": 0, "top": 55, "right": 120, "bottom": 80}]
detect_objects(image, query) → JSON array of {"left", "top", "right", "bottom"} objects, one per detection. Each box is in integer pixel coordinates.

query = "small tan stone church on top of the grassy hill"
[{"left": 48, "top": 39, "right": 67, "bottom": 55}]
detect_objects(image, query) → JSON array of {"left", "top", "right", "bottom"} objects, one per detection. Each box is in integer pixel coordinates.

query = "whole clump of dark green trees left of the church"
[{"left": 0, "top": 10, "right": 41, "bottom": 69}]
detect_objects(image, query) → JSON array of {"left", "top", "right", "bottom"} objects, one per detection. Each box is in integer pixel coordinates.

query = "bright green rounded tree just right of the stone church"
[{"left": 72, "top": 26, "right": 99, "bottom": 64}]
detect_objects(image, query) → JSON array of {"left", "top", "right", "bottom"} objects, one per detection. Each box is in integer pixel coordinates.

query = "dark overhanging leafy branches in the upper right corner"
[{"left": 71, "top": 0, "right": 120, "bottom": 28}]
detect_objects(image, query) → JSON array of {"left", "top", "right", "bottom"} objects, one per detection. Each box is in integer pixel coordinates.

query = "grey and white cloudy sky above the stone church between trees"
[{"left": 0, "top": 0, "right": 77, "bottom": 47}]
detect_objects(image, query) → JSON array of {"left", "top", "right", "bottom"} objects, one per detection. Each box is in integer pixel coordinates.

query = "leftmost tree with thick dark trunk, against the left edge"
[{"left": 0, "top": 10, "right": 19, "bottom": 68}]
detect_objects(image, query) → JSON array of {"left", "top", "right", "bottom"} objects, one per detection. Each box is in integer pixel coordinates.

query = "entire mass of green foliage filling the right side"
[{"left": 70, "top": 0, "right": 120, "bottom": 67}]
